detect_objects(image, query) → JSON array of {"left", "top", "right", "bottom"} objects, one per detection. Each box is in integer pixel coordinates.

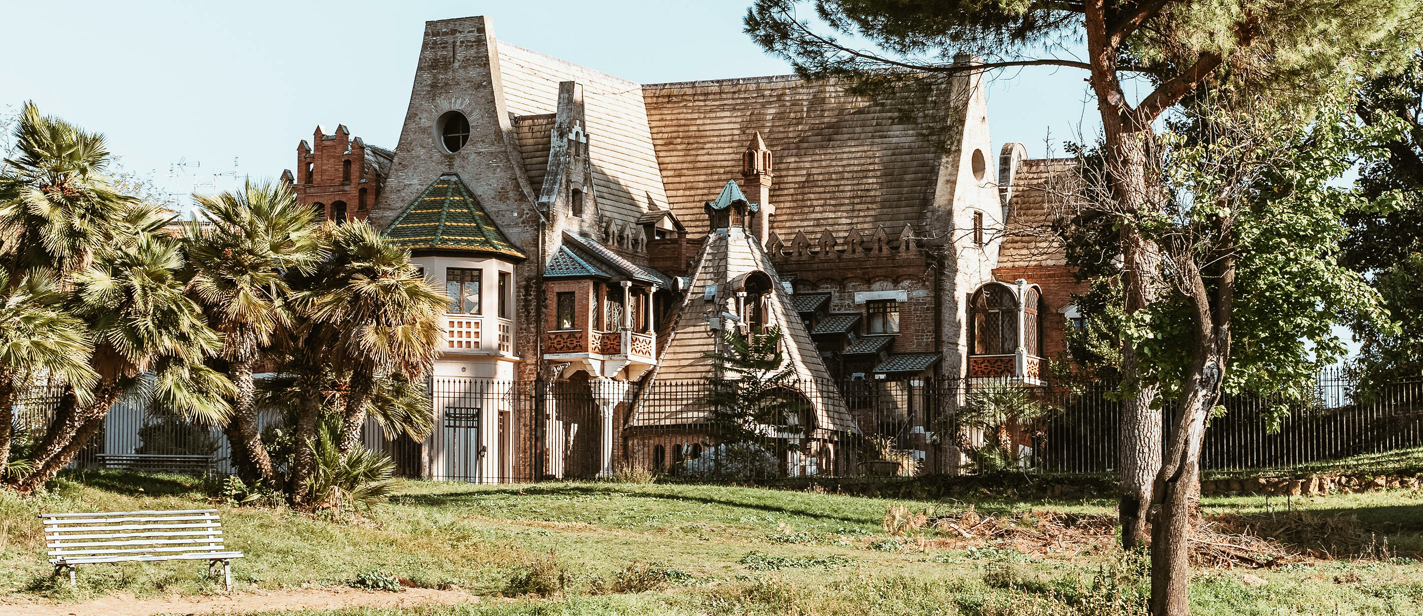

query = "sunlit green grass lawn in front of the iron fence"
[{"left": 0, "top": 472, "right": 1422, "bottom": 616}]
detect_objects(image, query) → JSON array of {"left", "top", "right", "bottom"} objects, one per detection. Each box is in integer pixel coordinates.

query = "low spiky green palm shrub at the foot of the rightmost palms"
[{"left": 308, "top": 421, "right": 396, "bottom": 515}]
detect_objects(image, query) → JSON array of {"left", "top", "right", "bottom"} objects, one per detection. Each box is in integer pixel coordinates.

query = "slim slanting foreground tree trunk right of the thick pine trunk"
[{"left": 1151, "top": 354, "right": 1226, "bottom": 616}]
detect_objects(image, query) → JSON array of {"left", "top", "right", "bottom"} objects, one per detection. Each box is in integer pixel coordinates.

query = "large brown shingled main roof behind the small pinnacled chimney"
[{"left": 643, "top": 76, "right": 941, "bottom": 235}]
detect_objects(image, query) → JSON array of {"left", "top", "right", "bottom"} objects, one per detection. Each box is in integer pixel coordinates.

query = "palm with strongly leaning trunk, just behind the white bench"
[{"left": 11, "top": 229, "right": 234, "bottom": 492}]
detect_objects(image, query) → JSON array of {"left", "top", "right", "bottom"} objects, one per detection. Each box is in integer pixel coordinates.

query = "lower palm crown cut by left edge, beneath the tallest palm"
[{"left": 0, "top": 270, "right": 97, "bottom": 478}]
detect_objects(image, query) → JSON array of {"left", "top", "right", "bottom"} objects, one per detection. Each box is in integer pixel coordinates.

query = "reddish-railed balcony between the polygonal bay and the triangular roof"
[{"left": 544, "top": 329, "right": 657, "bottom": 381}]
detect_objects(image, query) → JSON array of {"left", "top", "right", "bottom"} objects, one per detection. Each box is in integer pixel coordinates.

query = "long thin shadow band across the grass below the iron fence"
[{"left": 390, "top": 483, "right": 881, "bottom": 525}]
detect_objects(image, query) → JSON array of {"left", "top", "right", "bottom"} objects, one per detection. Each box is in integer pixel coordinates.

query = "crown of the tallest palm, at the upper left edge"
[{"left": 0, "top": 103, "right": 137, "bottom": 284}]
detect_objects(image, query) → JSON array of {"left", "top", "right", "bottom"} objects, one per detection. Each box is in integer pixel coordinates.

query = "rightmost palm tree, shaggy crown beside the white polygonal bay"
[{"left": 295, "top": 221, "right": 438, "bottom": 453}]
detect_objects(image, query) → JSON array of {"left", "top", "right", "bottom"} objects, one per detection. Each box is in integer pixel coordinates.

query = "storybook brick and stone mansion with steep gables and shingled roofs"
[{"left": 282, "top": 17, "right": 1080, "bottom": 481}]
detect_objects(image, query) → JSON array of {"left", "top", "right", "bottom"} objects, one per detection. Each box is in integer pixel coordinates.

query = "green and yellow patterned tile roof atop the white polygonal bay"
[{"left": 382, "top": 174, "right": 524, "bottom": 260}]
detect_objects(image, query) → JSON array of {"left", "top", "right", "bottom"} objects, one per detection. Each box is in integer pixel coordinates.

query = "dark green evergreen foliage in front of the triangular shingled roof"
[{"left": 707, "top": 327, "right": 811, "bottom": 443}]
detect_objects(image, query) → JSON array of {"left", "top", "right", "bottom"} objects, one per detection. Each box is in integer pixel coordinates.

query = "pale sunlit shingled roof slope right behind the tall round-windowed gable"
[{"left": 497, "top": 41, "right": 668, "bottom": 222}]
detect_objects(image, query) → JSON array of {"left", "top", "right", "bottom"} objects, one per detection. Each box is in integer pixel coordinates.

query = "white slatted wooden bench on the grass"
[{"left": 40, "top": 509, "right": 242, "bottom": 590}]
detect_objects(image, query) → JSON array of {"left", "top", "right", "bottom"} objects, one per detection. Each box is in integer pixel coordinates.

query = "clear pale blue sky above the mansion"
[{"left": 0, "top": 0, "right": 1097, "bottom": 209}]
